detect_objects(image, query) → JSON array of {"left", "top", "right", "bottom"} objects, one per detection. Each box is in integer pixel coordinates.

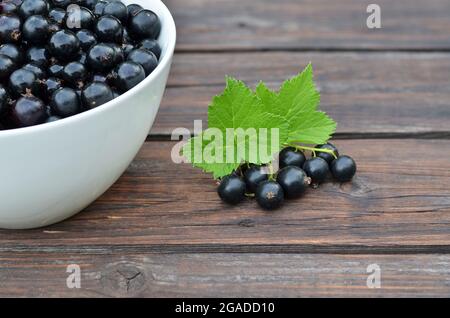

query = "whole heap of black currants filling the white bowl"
[{"left": 0, "top": 0, "right": 161, "bottom": 130}]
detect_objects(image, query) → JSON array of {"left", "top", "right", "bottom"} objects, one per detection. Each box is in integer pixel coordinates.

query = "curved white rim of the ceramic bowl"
[{"left": 0, "top": 0, "right": 177, "bottom": 139}]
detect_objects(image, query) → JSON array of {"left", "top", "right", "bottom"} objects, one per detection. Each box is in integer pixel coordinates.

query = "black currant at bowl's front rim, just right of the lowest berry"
[{"left": 50, "top": 87, "right": 81, "bottom": 118}]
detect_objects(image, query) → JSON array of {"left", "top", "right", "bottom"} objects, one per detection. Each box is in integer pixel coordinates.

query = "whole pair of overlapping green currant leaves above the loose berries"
[{"left": 182, "top": 64, "right": 336, "bottom": 178}]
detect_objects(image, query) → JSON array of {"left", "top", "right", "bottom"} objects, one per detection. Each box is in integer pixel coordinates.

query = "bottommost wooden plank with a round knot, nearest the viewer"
[{"left": 0, "top": 253, "right": 450, "bottom": 297}]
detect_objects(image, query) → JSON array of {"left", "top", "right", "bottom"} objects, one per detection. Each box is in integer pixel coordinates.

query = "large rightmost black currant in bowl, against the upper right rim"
[{"left": 129, "top": 10, "right": 161, "bottom": 40}]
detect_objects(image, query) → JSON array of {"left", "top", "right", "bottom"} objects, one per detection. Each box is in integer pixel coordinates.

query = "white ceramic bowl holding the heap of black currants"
[{"left": 0, "top": 0, "right": 176, "bottom": 229}]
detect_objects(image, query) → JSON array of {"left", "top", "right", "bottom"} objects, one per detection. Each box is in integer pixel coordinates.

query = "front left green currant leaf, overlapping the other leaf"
[{"left": 183, "top": 77, "right": 288, "bottom": 178}]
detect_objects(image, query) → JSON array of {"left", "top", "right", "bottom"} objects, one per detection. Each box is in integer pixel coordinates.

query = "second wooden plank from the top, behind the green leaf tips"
[{"left": 151, "top": 52, "right": 450, "bottom": 135}]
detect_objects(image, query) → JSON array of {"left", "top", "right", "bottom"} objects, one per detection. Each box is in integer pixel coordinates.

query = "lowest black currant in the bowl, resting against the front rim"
[{"left": 11, "top": 96, "right": 47, "bottom": 127}]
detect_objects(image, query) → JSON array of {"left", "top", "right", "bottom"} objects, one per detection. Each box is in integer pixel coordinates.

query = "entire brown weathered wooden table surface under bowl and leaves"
[{"left": 0, "top": 0, "right": 450, "bottom": 297}]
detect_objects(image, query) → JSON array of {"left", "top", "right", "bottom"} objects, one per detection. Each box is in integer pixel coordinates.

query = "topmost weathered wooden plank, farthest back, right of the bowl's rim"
[{"left": 164, "top": 0, "right": 450, "bottom": 51}]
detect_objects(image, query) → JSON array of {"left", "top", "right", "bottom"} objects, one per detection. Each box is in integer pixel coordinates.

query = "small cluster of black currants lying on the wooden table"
[{"left": 218, "top": 143, "right": 356, "bottom": 210}]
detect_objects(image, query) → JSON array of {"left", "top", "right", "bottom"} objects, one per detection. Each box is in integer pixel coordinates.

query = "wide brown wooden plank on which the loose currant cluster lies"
[{"left": 0, "top": 140, "right": 450, "bottom": 253}]
